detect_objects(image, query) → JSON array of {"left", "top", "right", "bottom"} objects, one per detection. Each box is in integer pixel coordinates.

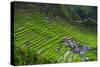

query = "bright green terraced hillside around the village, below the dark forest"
[{"left": 14, "top": 11, "right": 97, "bottom": 65}]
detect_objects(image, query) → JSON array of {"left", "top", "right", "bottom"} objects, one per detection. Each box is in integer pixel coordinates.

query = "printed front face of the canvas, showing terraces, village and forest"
[{"left": 12, "top": 1, "right": 97, "bottom": 65}]
